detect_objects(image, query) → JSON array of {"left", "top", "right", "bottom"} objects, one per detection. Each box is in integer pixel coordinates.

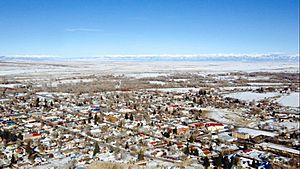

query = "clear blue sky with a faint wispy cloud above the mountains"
[{"left": 0, "top": 0, "right": 299, "bottom": 57}]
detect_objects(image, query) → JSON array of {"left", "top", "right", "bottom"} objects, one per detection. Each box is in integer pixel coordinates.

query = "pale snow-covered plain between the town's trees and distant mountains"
[{"left": 0, "top": 59, "right": 299, "bottom": 78}]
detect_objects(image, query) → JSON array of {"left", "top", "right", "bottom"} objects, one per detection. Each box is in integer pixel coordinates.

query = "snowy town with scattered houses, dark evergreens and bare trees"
[{"left": 0, "top": 72, "right": 300, "bottom": 168}]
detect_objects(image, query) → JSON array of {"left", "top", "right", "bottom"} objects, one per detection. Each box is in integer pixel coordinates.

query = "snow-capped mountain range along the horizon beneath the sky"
[{"left": 0, "top": 54, "right": 299, "bottom": 62}]
